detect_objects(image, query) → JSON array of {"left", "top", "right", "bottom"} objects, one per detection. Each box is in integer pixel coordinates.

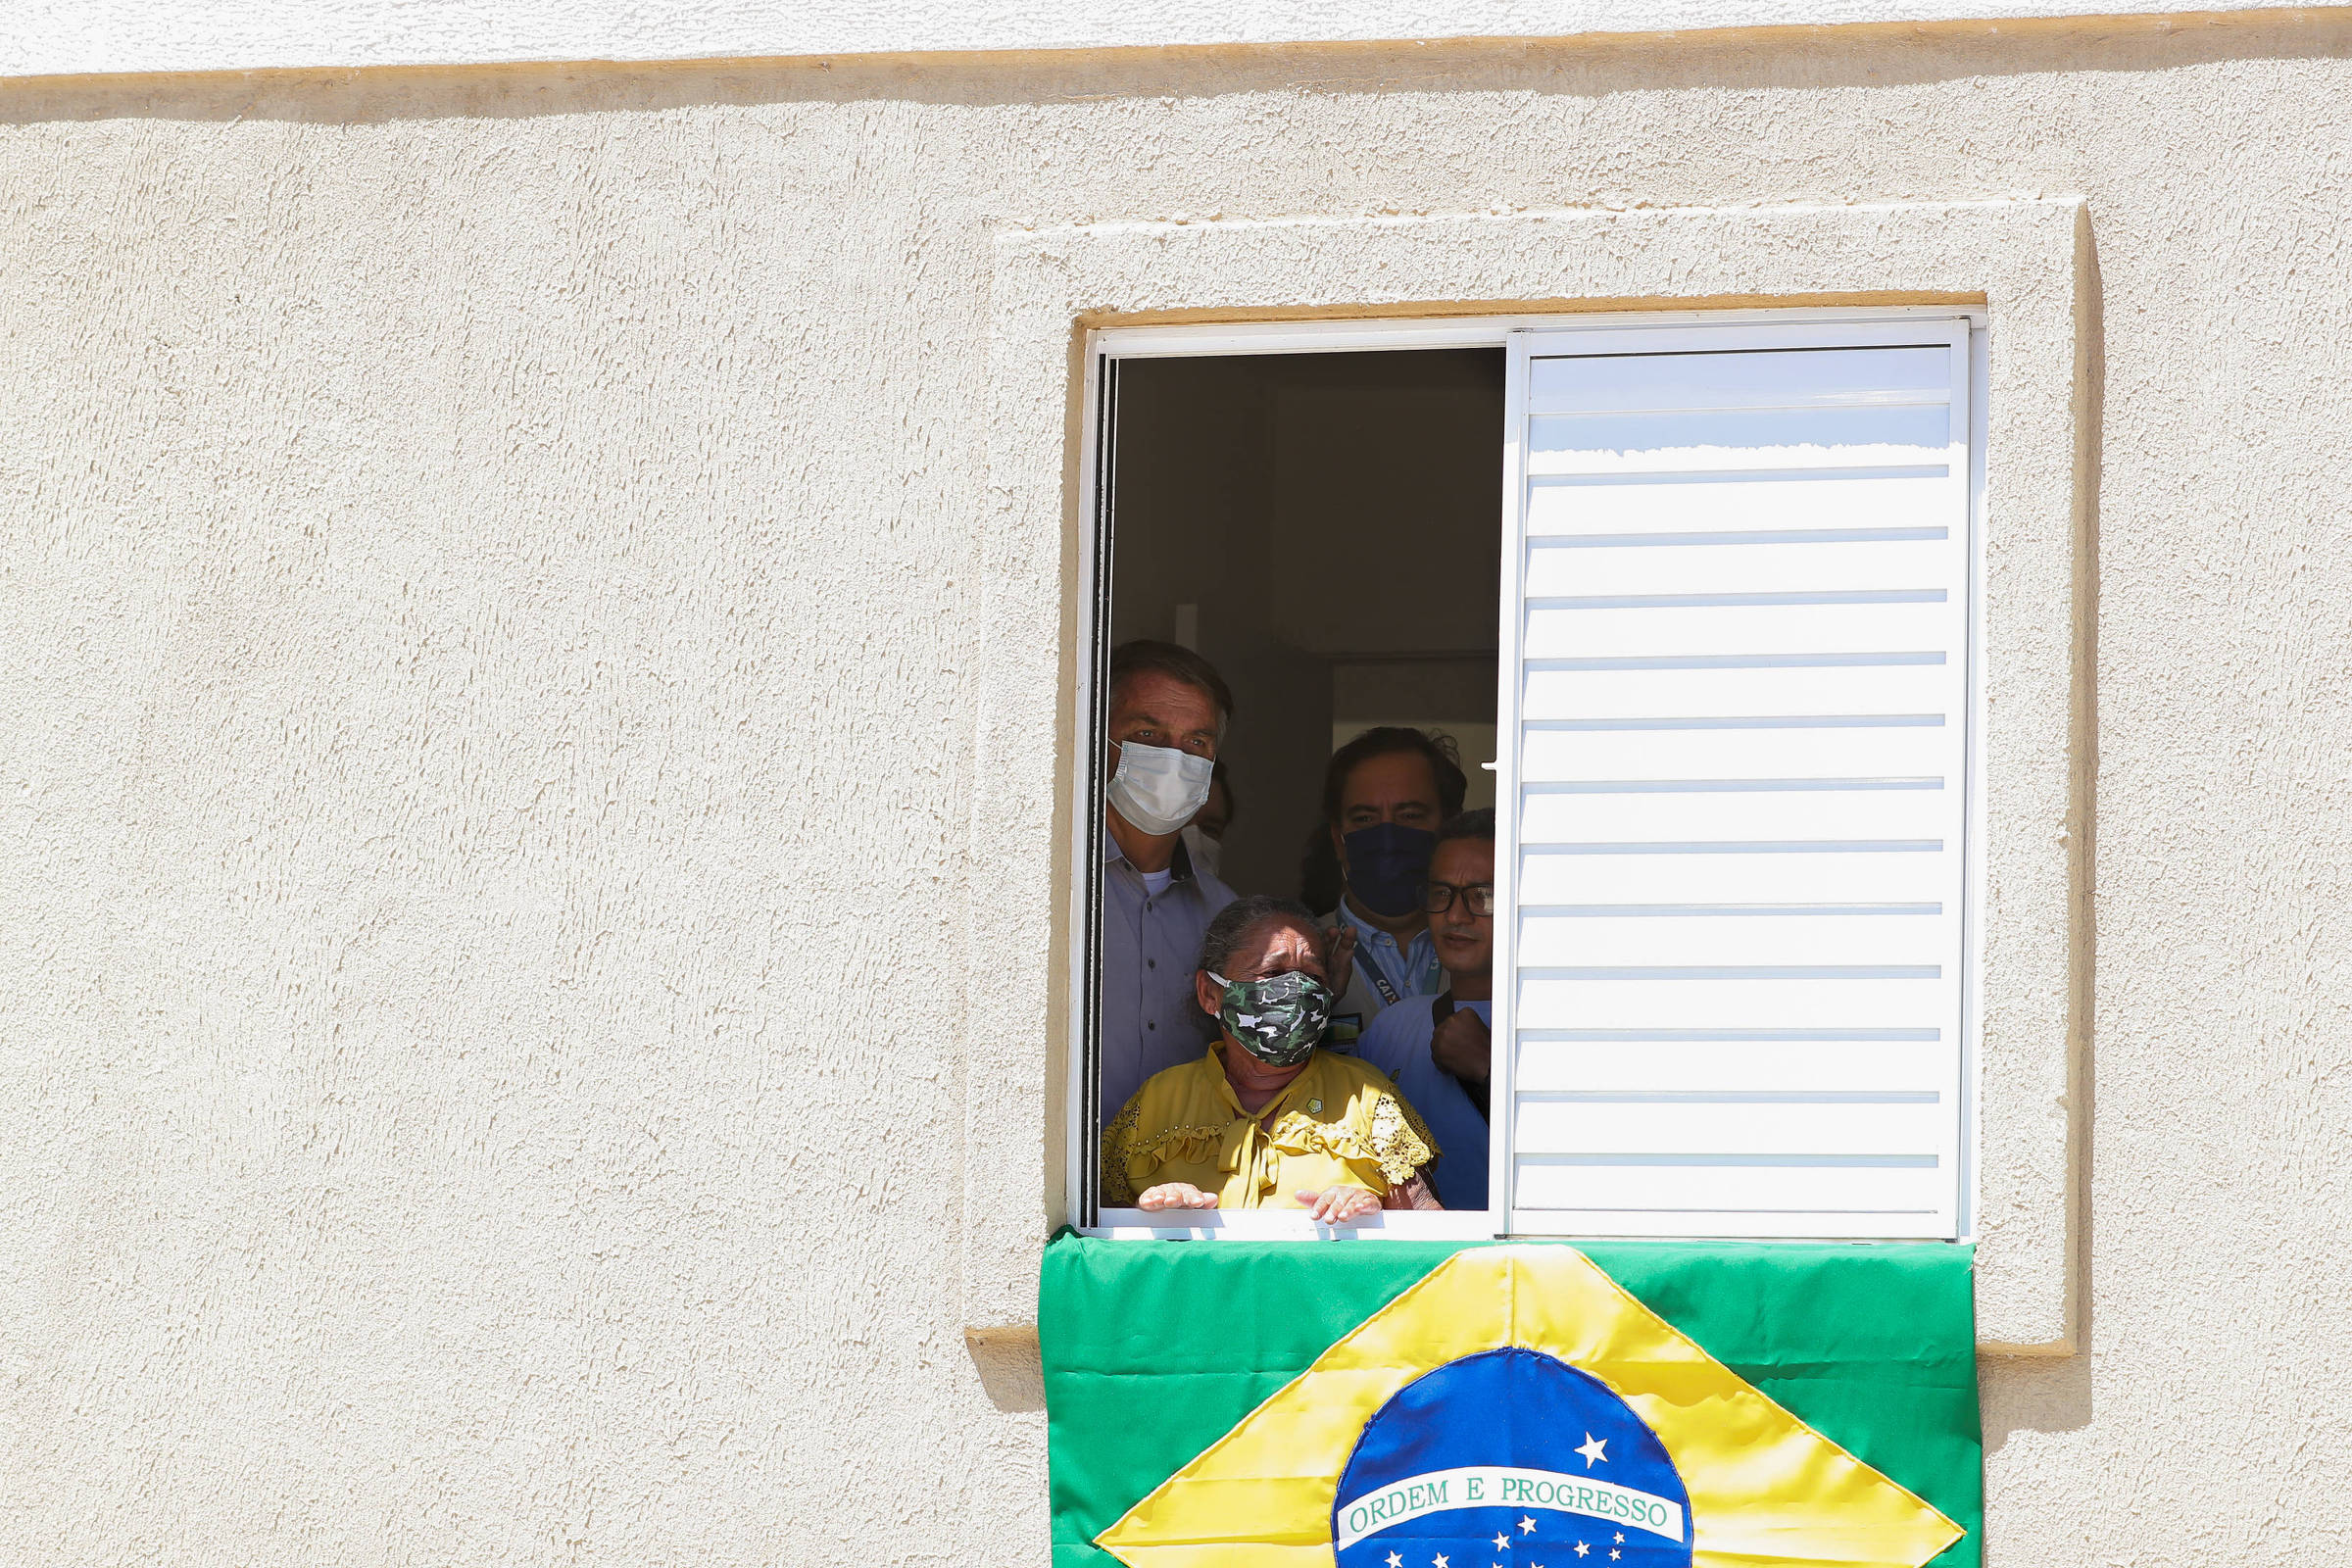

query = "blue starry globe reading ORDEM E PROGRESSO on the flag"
[{"left": 1331, "top": 1348, "right": 1691, "bottom": 1568}]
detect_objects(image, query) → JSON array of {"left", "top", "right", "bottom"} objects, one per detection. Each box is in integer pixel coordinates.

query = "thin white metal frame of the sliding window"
[{"left": 1063, "top": 306, "right": 1987, "bottom": 1242}]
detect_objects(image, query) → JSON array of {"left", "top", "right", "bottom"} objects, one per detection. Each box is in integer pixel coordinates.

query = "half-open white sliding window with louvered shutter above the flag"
[{"left": 1070, "top": 311, "right": 1981, "bottom": 1239}]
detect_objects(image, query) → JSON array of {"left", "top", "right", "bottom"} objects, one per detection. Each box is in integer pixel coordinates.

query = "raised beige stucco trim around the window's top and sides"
[{"left": 959, "top": 200, "right": 2098, "bottom": 1354}]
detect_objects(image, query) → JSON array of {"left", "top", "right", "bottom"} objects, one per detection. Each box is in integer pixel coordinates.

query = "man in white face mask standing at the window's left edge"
[{"left": 1096, "top": 642, "right": 1233, "bottom": 1121}]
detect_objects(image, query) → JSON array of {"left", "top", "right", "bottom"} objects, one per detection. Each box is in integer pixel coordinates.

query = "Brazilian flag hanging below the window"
[{"left": 1040, "top": 1234, "right": 1983, "bottom": 1568}]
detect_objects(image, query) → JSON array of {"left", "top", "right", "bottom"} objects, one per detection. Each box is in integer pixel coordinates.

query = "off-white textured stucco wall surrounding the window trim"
[{"left": 0, "top": 17, "right": 2352, "bottom": 1568}]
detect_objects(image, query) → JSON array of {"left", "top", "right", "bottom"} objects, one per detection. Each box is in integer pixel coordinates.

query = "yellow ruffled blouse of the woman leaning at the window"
[{"left": 1103, "top": 1042, "right": 1437, "bottom": 1208}]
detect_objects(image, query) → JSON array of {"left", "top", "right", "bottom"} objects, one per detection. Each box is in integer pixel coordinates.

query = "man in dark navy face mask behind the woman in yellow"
[{"left": 1324, "top": 724, "right": 1468, "bottom": 1051}]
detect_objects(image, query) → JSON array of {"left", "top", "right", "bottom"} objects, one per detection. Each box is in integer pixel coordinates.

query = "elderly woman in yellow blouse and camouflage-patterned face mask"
[{"left": 1103, "top": 896, "right": 1437, "bottom": 1225}]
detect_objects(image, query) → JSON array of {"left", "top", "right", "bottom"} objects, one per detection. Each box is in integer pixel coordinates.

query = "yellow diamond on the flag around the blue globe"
[{"left": 1096, "top": 1246, "right": 1962, "bottom": 1568}]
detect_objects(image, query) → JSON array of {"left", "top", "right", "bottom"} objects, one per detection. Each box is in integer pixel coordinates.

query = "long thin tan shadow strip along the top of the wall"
[{"left": 14, "top": 10, "right": 2352, "bottom": 124}]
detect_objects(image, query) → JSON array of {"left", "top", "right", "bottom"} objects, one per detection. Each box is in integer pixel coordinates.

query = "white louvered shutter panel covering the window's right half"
[{"left": 1498, "top": 318, "right": 1974, "bottom": 1237}]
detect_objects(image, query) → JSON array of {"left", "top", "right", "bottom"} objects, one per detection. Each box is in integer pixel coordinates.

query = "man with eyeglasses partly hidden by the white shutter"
[{"left": 1357, "top": 811, "right": 1494, "bottom": 1208}]
